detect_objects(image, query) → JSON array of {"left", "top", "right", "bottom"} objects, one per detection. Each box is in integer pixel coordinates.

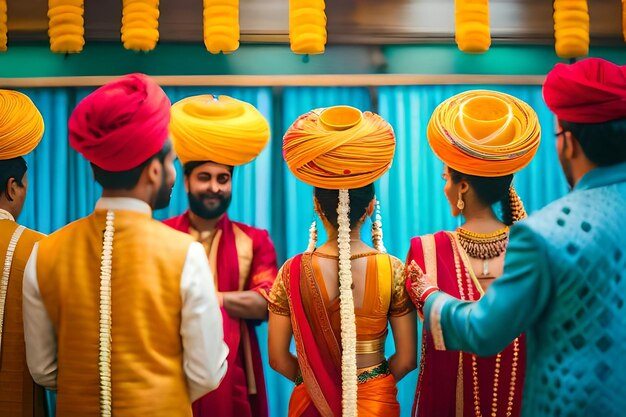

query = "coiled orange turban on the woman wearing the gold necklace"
[{"left": 427, "top": 90, "right": 541, "bottom": 177}]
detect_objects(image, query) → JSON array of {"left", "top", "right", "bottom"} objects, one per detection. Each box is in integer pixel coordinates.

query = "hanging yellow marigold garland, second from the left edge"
[{"left": 48, "top": 0, "right": 85, "bottom": 54}]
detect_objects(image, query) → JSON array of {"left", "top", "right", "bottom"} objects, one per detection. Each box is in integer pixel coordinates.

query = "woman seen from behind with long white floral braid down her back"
[{"left": 269, "top": 106, "right": 416, "bottom": 417}]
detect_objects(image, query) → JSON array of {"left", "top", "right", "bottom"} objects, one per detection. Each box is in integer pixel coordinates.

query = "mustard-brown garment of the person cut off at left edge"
[{"left": 0, "top": 219, "right": 44, "bottom": 417}]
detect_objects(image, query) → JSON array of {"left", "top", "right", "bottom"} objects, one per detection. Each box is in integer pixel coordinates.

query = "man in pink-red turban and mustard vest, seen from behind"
[{"left": 24, "top": 74, "right": 228, "bottom": 417}]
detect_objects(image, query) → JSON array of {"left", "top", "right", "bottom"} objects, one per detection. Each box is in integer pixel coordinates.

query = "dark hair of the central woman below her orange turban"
[{"left": 314, "top": 184, "right": 374, "bottom": 228}]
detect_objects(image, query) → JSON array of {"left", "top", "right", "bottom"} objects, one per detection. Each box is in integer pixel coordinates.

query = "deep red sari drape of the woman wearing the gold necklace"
[{"left": 407, "top": 232, "right": 526, "bottom": 417}]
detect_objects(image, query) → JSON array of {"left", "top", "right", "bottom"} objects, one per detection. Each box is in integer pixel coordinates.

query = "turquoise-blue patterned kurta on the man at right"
[{"left": 424, "top": 163, "right": 626, "bottom": 417}]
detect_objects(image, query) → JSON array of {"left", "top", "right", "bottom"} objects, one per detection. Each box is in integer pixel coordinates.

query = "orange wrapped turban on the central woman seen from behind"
[{"left": 283, "top": 106, "right": 396, "bottom": 190}]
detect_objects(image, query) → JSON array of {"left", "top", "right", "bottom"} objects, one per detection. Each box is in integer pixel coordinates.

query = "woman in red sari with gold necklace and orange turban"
[{"left": 406, "top": 90, "right": 540, "bottom": 417}]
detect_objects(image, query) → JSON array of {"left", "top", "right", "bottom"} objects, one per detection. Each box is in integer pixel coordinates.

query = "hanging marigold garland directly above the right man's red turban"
[{"left": 554, "top": 0, "right": 589, "bottom": 58}]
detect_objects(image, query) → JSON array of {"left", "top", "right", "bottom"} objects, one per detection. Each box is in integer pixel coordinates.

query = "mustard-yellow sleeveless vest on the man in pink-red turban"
[{"left": 37, "top": 210, "right": 195, "bottom": 417}]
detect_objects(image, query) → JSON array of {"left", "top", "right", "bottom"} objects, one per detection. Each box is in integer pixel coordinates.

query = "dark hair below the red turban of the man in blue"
[{"left": 559, "top": 118, "right": 626, "bottom": 166}]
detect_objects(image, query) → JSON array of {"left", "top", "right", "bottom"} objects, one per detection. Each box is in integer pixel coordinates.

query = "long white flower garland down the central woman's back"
[{"left": 337, "top": 190, "right": 357, "bottom": 417}]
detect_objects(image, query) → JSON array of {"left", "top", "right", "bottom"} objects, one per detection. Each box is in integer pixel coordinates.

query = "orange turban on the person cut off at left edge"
[{"left": 0, "top": 90, "right": 44, "bottom": 160}]
